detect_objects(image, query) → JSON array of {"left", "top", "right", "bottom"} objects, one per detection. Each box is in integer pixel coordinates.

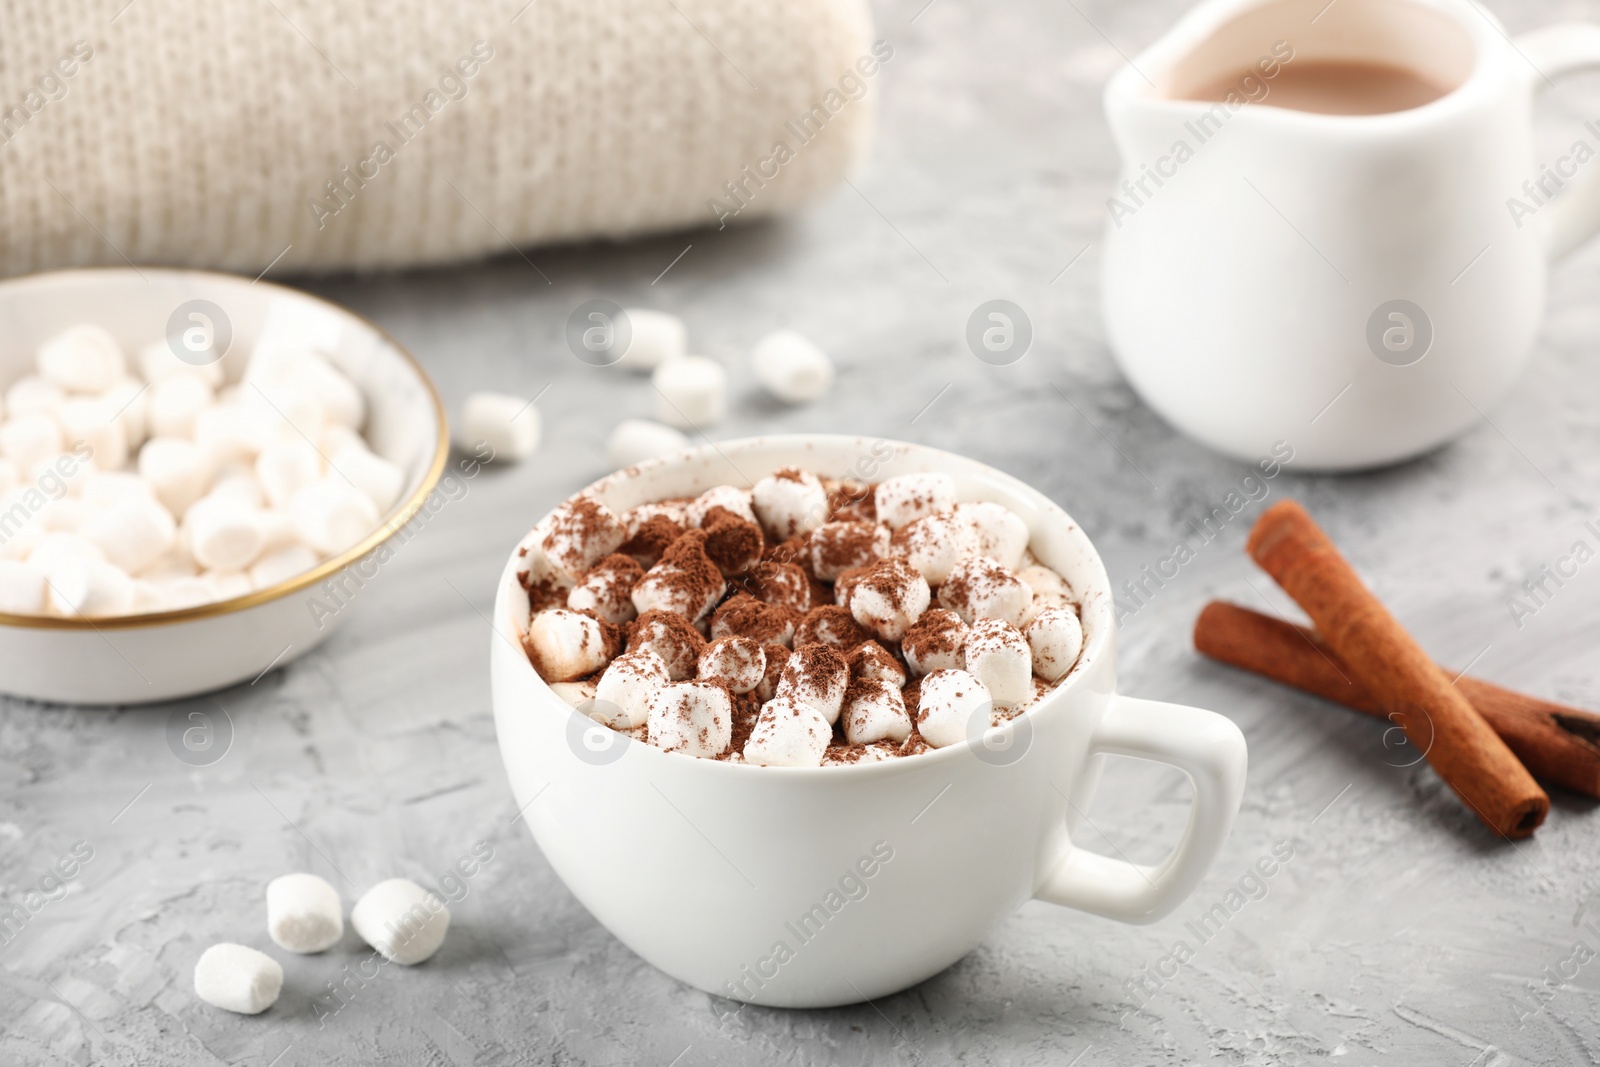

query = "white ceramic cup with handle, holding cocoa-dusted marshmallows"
[{"left": 490, "top": 435, "right": 1246, "bottom": 1008}]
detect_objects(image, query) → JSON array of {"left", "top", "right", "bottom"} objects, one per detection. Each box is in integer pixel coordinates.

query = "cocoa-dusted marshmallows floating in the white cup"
[{"left": 518, "top": 469, "right": 1083, "bottom": 766}]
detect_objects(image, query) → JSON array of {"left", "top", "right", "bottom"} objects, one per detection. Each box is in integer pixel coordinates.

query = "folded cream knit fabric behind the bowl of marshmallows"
[{"left": 0, "top": 0, "right": 876, "bottom": 274}]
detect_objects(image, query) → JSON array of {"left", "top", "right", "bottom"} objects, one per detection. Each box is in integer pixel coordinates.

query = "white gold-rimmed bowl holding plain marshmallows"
[{"left": 0, "top": 267, "right": 450, "bottom": 704}]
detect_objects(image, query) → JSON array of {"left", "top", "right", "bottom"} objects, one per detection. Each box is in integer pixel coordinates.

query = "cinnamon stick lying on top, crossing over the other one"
[{"left": 1246, "top": 501, "right": 1550, "bottom": 838}]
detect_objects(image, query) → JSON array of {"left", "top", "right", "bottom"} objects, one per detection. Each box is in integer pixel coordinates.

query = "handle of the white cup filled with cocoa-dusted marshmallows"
[{"left": 1034, "top": 696, "right": 1248, "bottom": 923}]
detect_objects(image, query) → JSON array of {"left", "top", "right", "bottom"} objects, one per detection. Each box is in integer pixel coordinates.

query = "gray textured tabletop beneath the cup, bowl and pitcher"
[{"left": 0, "top": 0, "right": 1600, "bottom": 1067}]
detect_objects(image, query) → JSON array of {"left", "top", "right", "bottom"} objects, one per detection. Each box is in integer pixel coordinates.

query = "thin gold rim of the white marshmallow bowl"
[{"left": 0, "top": 267, "right": 450, "bottom": 630}]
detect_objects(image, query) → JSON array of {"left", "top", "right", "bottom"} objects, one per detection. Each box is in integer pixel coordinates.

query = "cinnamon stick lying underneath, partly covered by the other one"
[{"left": 1195, "top": 600, "right": 1600, "bottom": 798}]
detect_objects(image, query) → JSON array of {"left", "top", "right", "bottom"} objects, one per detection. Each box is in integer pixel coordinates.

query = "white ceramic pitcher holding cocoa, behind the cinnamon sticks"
[{"left": 1102, "top": 0, "right": 1600, "bottom": 470}]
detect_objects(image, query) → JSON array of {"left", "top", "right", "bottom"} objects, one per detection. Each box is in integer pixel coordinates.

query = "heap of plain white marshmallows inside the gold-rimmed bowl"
[{"left": 0, "top": 323, "right": 405, "bottom": 617}]
